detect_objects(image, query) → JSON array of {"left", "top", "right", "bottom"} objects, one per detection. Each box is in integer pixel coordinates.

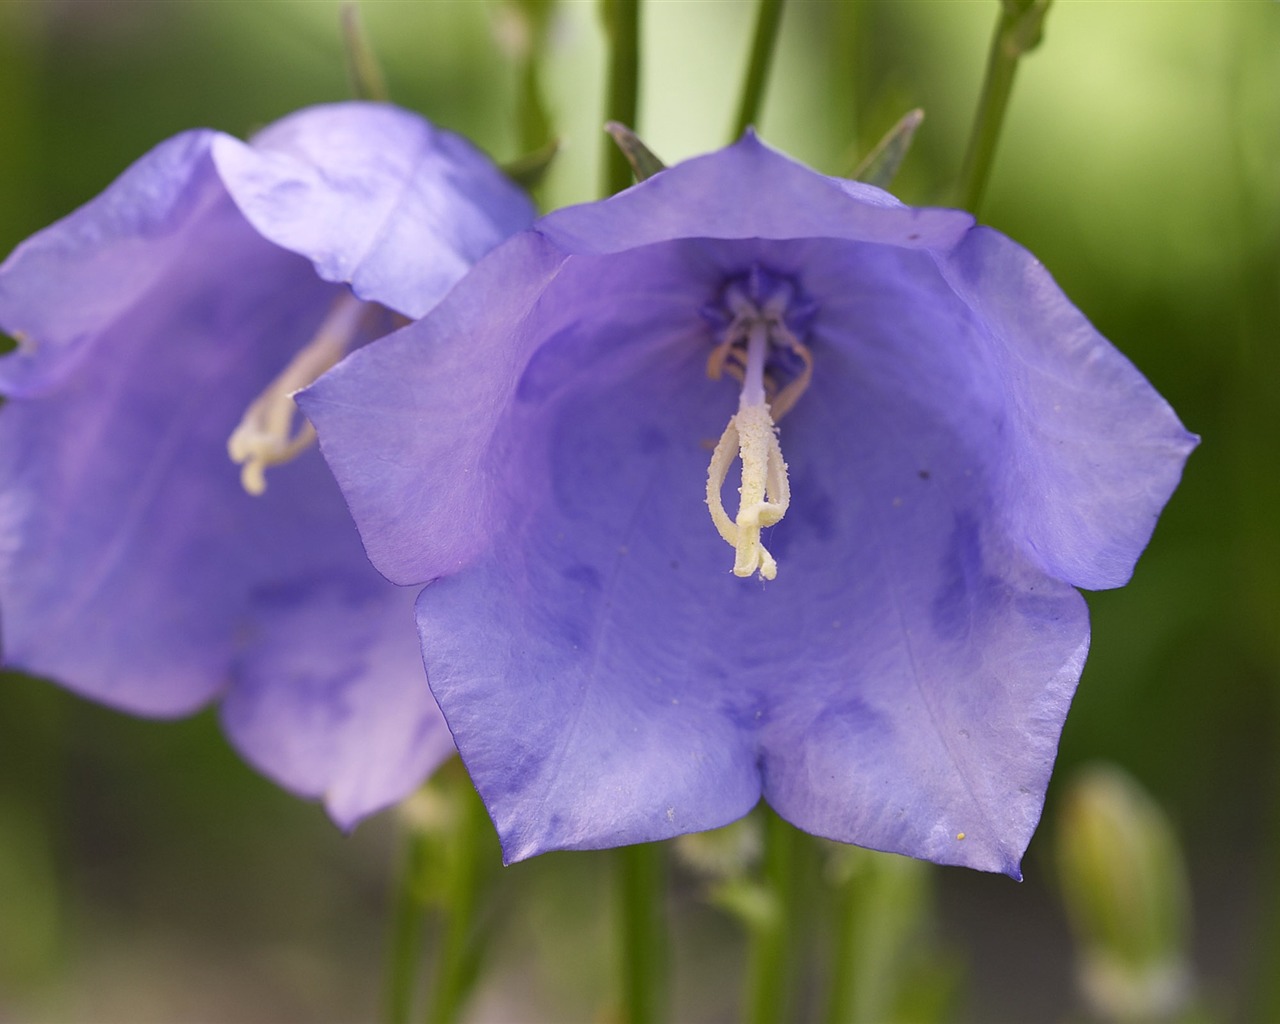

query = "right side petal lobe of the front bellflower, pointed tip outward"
[{"left": 940, "top": 228, "right": 1199, "bottom": 589}]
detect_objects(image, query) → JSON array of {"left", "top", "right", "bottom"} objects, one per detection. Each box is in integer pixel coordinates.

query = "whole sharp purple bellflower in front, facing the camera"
[{"left": 300, "top": 134, "right": 1196, "bottom": 877}]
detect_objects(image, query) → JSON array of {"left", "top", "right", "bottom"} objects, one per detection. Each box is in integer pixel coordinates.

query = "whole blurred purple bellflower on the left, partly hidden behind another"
[{"left": 0, "top": 102, "right": 532, "bottom": 827}]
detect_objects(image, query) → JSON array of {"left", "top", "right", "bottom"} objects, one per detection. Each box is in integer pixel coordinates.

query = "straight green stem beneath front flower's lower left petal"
[{"left": 618, "top": 842, "right": 667, "bottom": 1024}]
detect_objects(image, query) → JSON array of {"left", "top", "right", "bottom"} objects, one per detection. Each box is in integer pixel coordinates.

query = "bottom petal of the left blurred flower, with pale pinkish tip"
[{"left": 221, "top": 452, "right": 453, "bottom": 828}]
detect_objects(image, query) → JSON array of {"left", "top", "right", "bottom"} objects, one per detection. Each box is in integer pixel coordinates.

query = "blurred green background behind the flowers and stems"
[{"left": 0, "top": 0, "right": 1280, "bottom": 1023}]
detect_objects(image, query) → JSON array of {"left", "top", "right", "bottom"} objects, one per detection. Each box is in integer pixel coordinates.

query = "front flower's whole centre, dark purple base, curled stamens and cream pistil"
[{"left": 705, "top": 268, "right": 813, "bottom": 580}]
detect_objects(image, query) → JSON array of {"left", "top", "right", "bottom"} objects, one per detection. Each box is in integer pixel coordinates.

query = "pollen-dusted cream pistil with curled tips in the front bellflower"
[{"left": 707, "top": 319, "right": 791, "bottom": 580}]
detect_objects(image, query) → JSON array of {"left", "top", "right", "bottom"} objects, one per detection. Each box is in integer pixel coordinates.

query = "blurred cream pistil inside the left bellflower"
[{"left": 227, "top": 294, "right": 369, "bottom": 497}]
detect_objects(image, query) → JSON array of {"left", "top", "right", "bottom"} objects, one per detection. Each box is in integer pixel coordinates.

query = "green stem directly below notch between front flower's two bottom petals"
[{"left": 746, "top": 809, "right": 795, "bottom": 1024}]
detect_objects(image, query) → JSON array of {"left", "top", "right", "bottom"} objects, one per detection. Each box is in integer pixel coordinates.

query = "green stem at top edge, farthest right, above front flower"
[{"left": 959, "top": 0, "right": 1051, "bottom": 214}]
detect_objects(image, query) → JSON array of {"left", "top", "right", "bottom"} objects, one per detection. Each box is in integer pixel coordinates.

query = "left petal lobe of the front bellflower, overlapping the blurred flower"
[{"left": 297, "top": 234, "right": 573, "bottom": 585}]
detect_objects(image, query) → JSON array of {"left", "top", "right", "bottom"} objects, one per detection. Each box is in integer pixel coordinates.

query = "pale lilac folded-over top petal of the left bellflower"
[{"left": 214, "top": 102, "right": 534, "bottom": 317}]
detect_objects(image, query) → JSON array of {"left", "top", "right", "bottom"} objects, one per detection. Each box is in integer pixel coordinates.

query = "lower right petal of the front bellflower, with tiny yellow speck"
[{"left": 744, "top": 349, "right": 1089, "bottom": 877}]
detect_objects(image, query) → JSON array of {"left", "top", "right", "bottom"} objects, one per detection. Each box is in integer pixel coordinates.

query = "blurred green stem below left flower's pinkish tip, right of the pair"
[{"left": 424, "top": 783, "right": 489, "bottom": 1024}]
